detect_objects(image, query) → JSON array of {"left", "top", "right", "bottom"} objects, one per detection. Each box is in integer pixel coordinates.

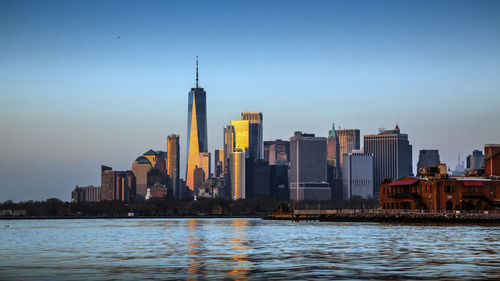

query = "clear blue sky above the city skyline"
[{"left": 0, "top": 0, "right": 500, "bottom": 202}]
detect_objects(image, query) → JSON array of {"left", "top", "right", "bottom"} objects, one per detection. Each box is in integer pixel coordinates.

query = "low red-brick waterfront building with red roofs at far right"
[{"left": 380, "top": 174, "right": 500, "bottom": 212}]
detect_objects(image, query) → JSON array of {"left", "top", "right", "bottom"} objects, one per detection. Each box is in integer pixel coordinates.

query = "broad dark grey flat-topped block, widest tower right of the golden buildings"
[{"left": 290, "top": 132, "right": 331, "bottom": 201}]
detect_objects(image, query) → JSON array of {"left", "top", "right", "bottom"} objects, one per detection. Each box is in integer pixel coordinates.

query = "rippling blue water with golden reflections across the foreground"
[{"left": 0, "top": 219, "right": 500, "bottom": 280}]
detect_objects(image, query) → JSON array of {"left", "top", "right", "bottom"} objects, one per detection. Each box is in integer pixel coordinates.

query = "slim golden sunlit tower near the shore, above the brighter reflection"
[{"left": 229, "top": 148, "right": 246, "bottom": 200}]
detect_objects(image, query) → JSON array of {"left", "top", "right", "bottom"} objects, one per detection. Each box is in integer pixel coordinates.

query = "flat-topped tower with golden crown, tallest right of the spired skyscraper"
[{"left": 241, "top": 112, "right": 264, "bottom": 159}]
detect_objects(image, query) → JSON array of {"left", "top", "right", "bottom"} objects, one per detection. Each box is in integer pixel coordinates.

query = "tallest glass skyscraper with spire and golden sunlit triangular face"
[{"left": 186, "top": 57, "right": 208, "bottom": 190}]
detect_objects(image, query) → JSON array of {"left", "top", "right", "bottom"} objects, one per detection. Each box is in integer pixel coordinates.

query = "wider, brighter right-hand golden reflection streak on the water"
[{"left": 229, "top": 220, "right": 252, "bottom": 280}]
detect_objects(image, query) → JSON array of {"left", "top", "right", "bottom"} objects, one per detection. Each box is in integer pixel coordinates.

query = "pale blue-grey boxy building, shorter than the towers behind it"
[{"left": 342, "top": 153, "right": 373, "bottom": 200}]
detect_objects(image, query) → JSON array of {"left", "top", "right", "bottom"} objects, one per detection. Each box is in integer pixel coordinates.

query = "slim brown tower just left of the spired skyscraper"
[{"left": 167, "top": 135, "right": 183, "bottom": 199}]
